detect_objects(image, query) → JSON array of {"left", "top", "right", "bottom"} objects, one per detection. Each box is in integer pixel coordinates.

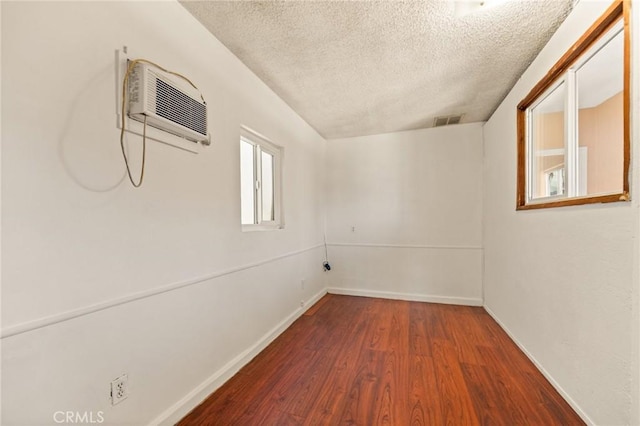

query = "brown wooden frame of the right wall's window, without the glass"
[{"left": 516, "top": 0, "right": 631, "bottom": 210}]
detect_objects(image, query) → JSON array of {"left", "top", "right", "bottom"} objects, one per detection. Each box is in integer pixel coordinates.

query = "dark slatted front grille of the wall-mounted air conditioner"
[{"left": 155, "top": 77, "right": 207, "bottom": 136}]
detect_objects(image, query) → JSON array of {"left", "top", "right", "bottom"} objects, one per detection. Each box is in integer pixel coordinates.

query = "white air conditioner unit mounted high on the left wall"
[{"left": 128, "top": 63, "right": 210, "bottom": 145}]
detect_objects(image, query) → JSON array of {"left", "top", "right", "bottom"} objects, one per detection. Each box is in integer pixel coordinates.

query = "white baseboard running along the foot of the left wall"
[{"left": 149, "top": 289, "right": 327, "bottom": 425}]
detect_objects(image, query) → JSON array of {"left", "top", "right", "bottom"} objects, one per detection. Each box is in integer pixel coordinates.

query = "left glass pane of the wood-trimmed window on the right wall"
[{"left": 529, "top": 82, "right": 566, "bottom": 198}]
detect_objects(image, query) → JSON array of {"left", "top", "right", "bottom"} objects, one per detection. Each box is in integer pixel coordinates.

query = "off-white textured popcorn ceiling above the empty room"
[{"left": 181, "top": 0, "right": 573, "bottom": 138}]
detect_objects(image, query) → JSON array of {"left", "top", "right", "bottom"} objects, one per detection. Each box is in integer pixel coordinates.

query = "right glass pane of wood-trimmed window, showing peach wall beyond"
[{"left": 576, "top": 29, "right": 624, "bottom": 195}]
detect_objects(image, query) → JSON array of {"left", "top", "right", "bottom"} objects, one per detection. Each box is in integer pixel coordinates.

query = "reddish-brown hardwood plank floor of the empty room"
[{"left": 179, "top": 295, "right": 584, "bottom": 426}]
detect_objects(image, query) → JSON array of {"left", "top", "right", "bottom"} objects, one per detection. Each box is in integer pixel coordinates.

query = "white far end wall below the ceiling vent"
[{"left": 327, "top": 123, "right": 482, "bottom": 305}]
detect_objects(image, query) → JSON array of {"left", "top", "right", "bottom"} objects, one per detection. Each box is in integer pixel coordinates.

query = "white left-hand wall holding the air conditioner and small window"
[{"left": 2, "top": 2, "right": 326, "bottom": 425}]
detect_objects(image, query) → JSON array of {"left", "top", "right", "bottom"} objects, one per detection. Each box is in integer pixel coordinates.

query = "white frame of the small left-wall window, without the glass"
[{"left": 239, "top": 126, "right": 284, "bottom": 231}]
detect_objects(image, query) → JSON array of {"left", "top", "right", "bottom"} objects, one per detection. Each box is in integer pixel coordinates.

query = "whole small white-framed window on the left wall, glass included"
[{"left": 240, "top": 127, "right": 283, "bottom": 231}]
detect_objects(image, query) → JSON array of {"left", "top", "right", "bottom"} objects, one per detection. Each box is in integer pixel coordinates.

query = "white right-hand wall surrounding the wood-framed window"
[{"left": 483, "top": 1, "right": 640, "bottom": 425}]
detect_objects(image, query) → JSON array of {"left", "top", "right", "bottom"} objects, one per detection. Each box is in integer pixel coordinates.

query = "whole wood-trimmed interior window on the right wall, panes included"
[{"left": 516, "top": 0, "right": 630, "bottom": 210}]
